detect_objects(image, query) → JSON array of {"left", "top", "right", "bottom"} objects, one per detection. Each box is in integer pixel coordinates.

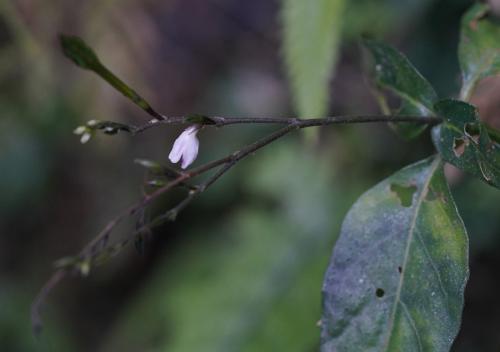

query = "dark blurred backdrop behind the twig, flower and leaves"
[{"left": 0, "top": 0, "right": 500, "bottom": 352}]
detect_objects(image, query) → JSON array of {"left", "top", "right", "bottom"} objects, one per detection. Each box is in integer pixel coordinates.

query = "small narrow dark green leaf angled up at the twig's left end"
[{"left": 60, "top": 35, "right": 165, "bottom": 120}]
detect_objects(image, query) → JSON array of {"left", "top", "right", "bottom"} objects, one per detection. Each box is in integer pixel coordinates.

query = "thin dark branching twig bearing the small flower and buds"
[{"left": 31, "top": 115, "right": 442, "bottom": 332}]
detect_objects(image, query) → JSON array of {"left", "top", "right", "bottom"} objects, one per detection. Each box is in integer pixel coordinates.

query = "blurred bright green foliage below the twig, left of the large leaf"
[{"left": 101, "top": 143, "right": 347, "bottom": 351}]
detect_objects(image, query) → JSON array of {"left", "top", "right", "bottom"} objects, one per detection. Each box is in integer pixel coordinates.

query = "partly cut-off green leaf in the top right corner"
[{"left": 458, "top": 3, "right": 500, "bottom": 100}]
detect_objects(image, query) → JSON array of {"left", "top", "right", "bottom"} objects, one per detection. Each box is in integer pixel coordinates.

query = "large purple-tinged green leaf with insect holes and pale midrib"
[{"left": 321, "top": 157, "right": 468, "bottom": 352}]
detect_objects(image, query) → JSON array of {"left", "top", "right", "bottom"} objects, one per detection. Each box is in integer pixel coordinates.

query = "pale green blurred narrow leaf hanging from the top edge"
[{"left": 282, "top": 0, "right": 344, "bottom": 117}]
